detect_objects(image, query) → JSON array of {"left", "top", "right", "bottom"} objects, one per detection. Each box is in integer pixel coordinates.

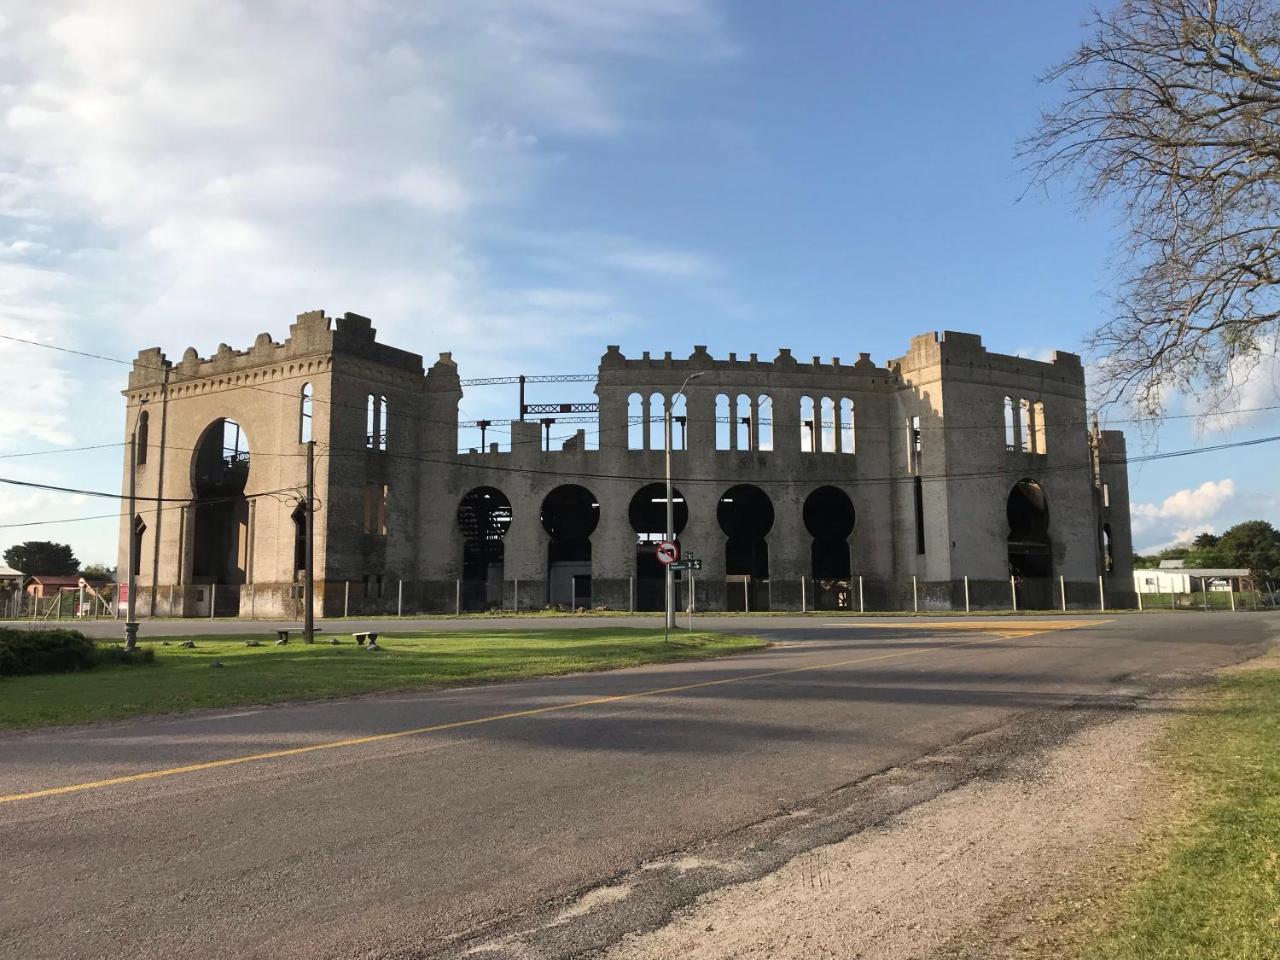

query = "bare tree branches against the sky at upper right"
[{"left": 1023, "top": 0, "right": 1280, "bottom": 412}]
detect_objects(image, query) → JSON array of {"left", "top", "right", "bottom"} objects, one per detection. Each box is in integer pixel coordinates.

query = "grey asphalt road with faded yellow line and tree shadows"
[{"left": 0, "top": 613, "right": 1280, "bottom": 959}]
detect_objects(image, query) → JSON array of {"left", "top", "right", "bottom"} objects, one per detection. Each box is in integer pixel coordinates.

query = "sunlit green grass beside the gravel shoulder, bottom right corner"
[{"left": 1080, "top": 668, "right": 1280, "bottom": 960}]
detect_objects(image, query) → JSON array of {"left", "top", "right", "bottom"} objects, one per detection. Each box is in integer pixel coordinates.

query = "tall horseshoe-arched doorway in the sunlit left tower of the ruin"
[{"left": 191, "top": 417, "right": 250, "bottom": 617}]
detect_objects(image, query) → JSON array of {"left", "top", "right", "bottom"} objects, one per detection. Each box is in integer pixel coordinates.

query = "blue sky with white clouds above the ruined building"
[{"left": 0, "top": 0, "right": 1280, "bottom": 561}]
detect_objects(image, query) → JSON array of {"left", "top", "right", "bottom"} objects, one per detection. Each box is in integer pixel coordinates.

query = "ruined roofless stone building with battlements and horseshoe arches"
[{"left": 119, "top": 311, "right": 1133, "bottom": 617}]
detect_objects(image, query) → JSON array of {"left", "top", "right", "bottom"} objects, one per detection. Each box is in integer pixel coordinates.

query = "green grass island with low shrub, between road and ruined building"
[{"left": 0, "top": 627, "right": 764, "bottom": 728}]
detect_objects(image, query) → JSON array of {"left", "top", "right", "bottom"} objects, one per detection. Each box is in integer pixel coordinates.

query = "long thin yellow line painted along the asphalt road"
[{"left": 0, "top": 621, "right": 1096, "bottom": 804}]
